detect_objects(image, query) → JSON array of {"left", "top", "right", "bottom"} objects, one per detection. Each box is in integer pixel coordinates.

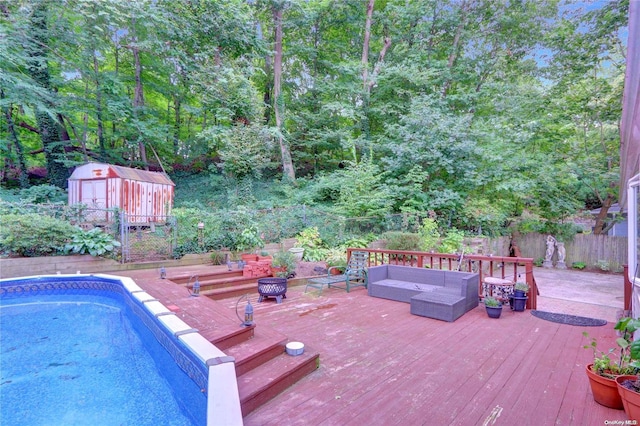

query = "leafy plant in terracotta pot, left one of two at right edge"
[{"left": 582, "top": 317, "right": 640, "bottom": 410}]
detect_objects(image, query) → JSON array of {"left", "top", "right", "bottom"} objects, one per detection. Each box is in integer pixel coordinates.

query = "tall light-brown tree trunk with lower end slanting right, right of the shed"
[{"left": 273, "top": 6, "right": 296, "bottom": 182}]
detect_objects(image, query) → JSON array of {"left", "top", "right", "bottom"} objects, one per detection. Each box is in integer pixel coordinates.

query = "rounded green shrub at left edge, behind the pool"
[{"left": 0, "top": 213, "right": 78, "bottom": 257}]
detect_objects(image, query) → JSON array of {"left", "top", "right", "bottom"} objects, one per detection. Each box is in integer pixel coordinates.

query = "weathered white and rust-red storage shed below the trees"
[{"left": 68, "top": 163, "right": 175, "bottom": 223}]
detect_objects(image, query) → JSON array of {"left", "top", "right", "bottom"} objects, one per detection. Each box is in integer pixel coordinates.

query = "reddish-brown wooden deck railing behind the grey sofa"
[{"left": 347, "top": 248, "right": 539, "bottom": 309}]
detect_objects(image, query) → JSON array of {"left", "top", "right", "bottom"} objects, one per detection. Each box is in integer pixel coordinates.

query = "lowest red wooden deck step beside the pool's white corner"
[{"left": 238, "top": 347, "right": 320, "bottom": 416}]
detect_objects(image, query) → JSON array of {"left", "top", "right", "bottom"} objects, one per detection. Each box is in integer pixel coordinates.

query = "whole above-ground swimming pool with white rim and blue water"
[{"left": 0, "top": 275, "right": 242, "bottom": 425}]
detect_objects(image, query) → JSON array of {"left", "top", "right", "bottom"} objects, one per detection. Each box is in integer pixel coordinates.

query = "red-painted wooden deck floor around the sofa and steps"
[{"left": 121, "top": 264, "right": 626, "bottom": 426}]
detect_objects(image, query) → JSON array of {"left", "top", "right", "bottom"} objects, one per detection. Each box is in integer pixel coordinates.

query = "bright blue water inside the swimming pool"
[{"left": 0, "top": 276, "right": 206, "bottom": 425}]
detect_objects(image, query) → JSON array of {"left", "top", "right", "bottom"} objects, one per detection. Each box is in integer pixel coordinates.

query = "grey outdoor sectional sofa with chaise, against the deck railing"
[{"left": 368, "top": 265, "right": 480, "bottom": 322}]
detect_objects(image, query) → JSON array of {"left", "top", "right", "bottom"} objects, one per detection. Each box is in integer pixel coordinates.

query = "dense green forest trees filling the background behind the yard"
[{"left": 0, "top": 0, "right": 628, "bottom": 234}]
